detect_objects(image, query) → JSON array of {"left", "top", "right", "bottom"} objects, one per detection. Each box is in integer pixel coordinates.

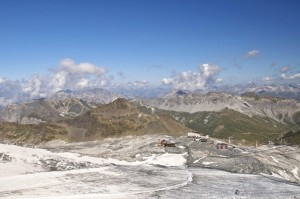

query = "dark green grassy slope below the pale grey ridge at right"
[{"left": 162, "top": 108, "right": 299, "bottom": 144}]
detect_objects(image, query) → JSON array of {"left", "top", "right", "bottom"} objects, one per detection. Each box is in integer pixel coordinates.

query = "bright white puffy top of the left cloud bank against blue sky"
[{"left": 60, "top": 59, "right": 105, "bottom": 75}]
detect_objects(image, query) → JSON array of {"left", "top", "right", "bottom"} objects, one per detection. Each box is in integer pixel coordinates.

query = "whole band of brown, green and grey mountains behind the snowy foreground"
[{"left": 0, "top": 85, "right": 300, "bottom": 143}]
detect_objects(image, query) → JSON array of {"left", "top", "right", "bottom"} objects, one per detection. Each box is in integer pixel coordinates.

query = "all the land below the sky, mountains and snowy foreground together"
[{"left": 0, "top": 90, "right": 300, "bottom": 199}]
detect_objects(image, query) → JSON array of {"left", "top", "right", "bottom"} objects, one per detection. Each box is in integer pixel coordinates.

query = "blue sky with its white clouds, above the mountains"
[{"left": 0, "top": 0, "right": 300, "bottom": 94}]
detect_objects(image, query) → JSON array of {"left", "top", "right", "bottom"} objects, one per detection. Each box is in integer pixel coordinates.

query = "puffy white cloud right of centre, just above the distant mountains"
[{"left": 161, "top": 64, "right": 222, "bottom": 90}]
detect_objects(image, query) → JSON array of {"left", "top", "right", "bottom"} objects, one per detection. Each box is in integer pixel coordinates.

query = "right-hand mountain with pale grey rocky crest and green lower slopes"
[{"left": 143, "top": 91, "right": 300, "bottom": 145}]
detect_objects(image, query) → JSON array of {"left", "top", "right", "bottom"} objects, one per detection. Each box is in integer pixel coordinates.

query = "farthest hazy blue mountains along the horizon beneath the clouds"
[{"left": 0, "top": 83, "right": 300, "bottom": 111}]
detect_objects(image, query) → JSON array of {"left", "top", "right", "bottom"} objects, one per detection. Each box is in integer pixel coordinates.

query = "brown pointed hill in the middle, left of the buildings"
[{"left": 67, "top": 98, "right": 189, "bottom": 138}]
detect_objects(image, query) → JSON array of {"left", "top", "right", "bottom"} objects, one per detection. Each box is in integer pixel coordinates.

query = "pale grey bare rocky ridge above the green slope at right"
[{"left": 144, "top": 92, "right": 300, "bottom": 123}]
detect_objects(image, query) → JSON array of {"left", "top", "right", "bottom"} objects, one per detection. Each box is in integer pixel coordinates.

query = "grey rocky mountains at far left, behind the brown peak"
[{"left": 0, "top": 88, "right": 118, "bottom": 124}]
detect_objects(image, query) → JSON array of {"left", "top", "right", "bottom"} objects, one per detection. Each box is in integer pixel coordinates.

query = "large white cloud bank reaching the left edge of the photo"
[{"left": 0, "top": 59, "right": 111, "bottom": 106}]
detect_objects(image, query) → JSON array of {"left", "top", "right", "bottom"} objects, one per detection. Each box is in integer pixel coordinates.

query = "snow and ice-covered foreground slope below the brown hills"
[{"left": 0, "top": 136, "right": 300, "bottom": 199}]
